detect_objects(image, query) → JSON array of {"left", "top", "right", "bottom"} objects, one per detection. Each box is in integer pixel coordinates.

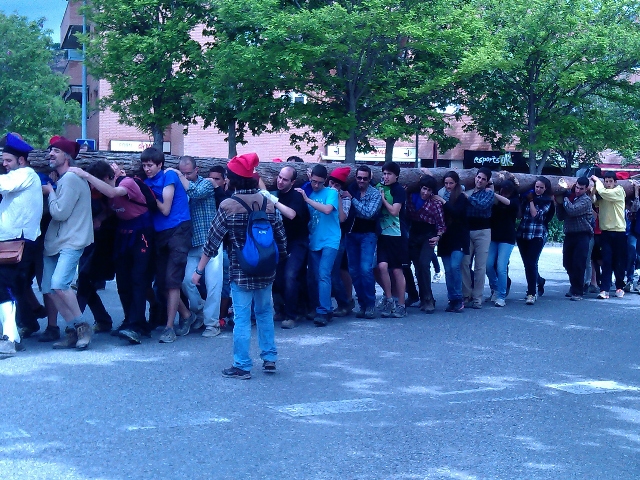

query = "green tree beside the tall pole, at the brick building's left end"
[{"left": 81, "top": 0, "right": 208, "bottom": 149}]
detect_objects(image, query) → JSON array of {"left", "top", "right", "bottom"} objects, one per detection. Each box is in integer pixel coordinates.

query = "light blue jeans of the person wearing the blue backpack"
[{"left": 231, "top": 282, "right": 278, "bottom": 371}]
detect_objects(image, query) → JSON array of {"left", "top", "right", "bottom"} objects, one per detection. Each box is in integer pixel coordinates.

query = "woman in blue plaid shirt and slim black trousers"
[{"left": 517, "top": 176, "right": 555, "bottom": 305}]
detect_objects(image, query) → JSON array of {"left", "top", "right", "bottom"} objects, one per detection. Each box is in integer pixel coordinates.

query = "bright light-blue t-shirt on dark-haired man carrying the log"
[{"left": 309, "top": 187, "right": 340, "bottom": 252}]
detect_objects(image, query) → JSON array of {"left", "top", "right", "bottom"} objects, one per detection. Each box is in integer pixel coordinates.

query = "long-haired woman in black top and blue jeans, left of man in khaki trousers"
[{"left": 434, "top": 171, "right": 469, "bottom": 313}]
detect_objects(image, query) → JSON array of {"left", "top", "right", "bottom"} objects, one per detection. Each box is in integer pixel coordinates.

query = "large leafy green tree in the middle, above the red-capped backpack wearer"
[{"left": 219, "top": 0, "right": 482, "bottom": 162}]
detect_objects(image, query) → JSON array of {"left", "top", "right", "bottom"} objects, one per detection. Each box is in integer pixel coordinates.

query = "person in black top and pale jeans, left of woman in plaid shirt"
[{"left": 487, "top": 180, "right": 520, "bottom": 307}]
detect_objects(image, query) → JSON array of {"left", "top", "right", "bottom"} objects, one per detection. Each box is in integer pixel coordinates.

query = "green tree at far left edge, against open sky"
[{"left": 0, "top": 12, "right": 80, "bottom": 146}]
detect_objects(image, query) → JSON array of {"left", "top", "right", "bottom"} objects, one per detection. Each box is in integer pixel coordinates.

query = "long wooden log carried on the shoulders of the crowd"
[{"left": 29, "top": 150, "right": 634, "bottom": 196}]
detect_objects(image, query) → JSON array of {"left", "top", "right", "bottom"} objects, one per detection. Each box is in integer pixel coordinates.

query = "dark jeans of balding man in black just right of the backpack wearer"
[{"left": 275, "top": 239, "right": 309, "bottom": 319}]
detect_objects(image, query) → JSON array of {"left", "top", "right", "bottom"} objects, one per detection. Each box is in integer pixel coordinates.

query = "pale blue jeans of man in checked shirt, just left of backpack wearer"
[{"left": 182, "top": 246, "right": 222, "bottom": 327}]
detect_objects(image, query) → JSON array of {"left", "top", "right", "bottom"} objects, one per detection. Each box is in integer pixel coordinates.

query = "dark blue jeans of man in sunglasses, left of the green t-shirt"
[{"left": 347, "top": 233, "right": 378, "bottom": 309}]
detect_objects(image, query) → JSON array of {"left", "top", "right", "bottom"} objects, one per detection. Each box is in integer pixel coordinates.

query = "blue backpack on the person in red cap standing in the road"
[{"left": 231, "top": 195, "right": 279, "bottom": 277}]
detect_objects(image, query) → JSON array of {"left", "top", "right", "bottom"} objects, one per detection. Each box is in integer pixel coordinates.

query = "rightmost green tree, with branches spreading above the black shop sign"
[{"left": 461, "top": 0, "right": 640, "bottom": 174}]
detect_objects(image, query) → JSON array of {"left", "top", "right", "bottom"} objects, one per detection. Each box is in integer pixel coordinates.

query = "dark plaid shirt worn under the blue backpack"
[{"left": 203, "top": 189, "right": 287, "bottom": 290}]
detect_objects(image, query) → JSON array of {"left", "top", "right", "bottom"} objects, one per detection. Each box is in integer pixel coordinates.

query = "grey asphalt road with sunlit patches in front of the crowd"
[{"left": 0, "top": 247, "right": 640, "bottom": 480}]
